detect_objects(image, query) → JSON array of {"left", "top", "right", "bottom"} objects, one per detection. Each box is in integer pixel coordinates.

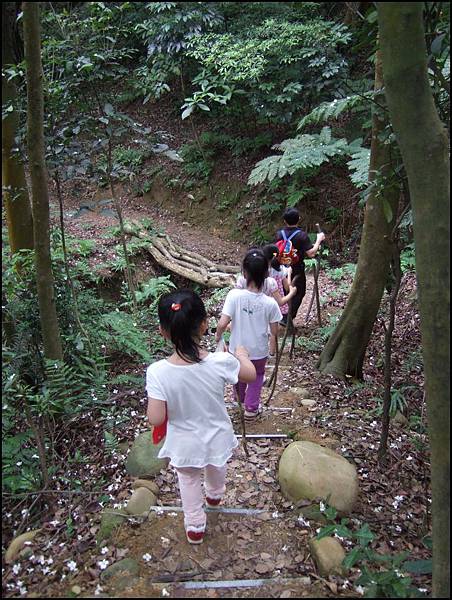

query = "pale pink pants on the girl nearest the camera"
[{"left": 176, "top": 465, "right": 226, "bottom": 532}]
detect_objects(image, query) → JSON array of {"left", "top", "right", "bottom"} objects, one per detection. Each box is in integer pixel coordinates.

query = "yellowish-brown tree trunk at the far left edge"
[{"left": 2, "top": 2, "right": 33, "bottom": 253}]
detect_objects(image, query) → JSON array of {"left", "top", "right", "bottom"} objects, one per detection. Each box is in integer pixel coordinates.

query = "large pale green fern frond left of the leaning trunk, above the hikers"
[{"left": 248, "top": 127, "right": 348, "bottom": 185}]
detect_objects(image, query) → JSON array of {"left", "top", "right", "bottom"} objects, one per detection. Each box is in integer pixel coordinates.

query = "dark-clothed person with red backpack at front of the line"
[{"left": 276, "top": 208, "right": 325, "bottom": 325}]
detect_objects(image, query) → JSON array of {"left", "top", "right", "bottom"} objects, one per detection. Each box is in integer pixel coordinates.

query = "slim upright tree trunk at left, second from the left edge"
[{"left": 23, "top": 2, "right": 63, "bottom": 360}]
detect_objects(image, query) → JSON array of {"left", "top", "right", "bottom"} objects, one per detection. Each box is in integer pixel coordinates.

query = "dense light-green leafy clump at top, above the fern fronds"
[{"left": 187, "top": 17, "right": 350, "bottom": 122}]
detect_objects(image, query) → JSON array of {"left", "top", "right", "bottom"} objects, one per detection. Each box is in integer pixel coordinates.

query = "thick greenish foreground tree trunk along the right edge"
[{"left": 377, "top": 2, "right": 450, "bottom": 598}]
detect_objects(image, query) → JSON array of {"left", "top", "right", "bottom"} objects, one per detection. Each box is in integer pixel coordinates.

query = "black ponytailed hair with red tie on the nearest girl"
[{"left": 158, "top": 289, "right": 207, "bottom": 363}]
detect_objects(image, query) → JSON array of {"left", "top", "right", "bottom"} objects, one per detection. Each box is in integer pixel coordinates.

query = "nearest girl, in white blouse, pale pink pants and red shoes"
[{"left": 146, "top": 290, "right": 256, "bottom": 544}]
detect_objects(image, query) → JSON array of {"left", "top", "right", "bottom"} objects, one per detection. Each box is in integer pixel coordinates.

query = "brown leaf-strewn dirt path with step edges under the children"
[{"left": 85, "top": 344, "right": 346, "bottom": 598}]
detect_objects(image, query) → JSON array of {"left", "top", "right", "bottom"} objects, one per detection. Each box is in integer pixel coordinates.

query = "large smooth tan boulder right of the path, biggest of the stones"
[{"left": 278, "top": 441, "right": 358, "bottom": 514}]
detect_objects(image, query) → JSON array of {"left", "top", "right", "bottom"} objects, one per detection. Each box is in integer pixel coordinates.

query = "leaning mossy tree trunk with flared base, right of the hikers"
[{"left": 317, "top": 52, "right": 400, "bottom": 379}]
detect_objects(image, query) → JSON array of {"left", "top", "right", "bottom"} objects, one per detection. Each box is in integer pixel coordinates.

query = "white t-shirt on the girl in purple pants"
[{"left": 221, "top": 289, "right": 282, "bottom": 360}]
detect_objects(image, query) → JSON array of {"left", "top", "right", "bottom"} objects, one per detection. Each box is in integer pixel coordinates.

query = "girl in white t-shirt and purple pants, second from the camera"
[{"left": 216, "top": 250, "right": 282, "bottom": 420}]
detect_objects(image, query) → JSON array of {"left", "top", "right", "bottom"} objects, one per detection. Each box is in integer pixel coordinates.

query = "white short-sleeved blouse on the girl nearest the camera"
[{"left": 146, "top": 352, "right": 240, "bottom": 467}]
